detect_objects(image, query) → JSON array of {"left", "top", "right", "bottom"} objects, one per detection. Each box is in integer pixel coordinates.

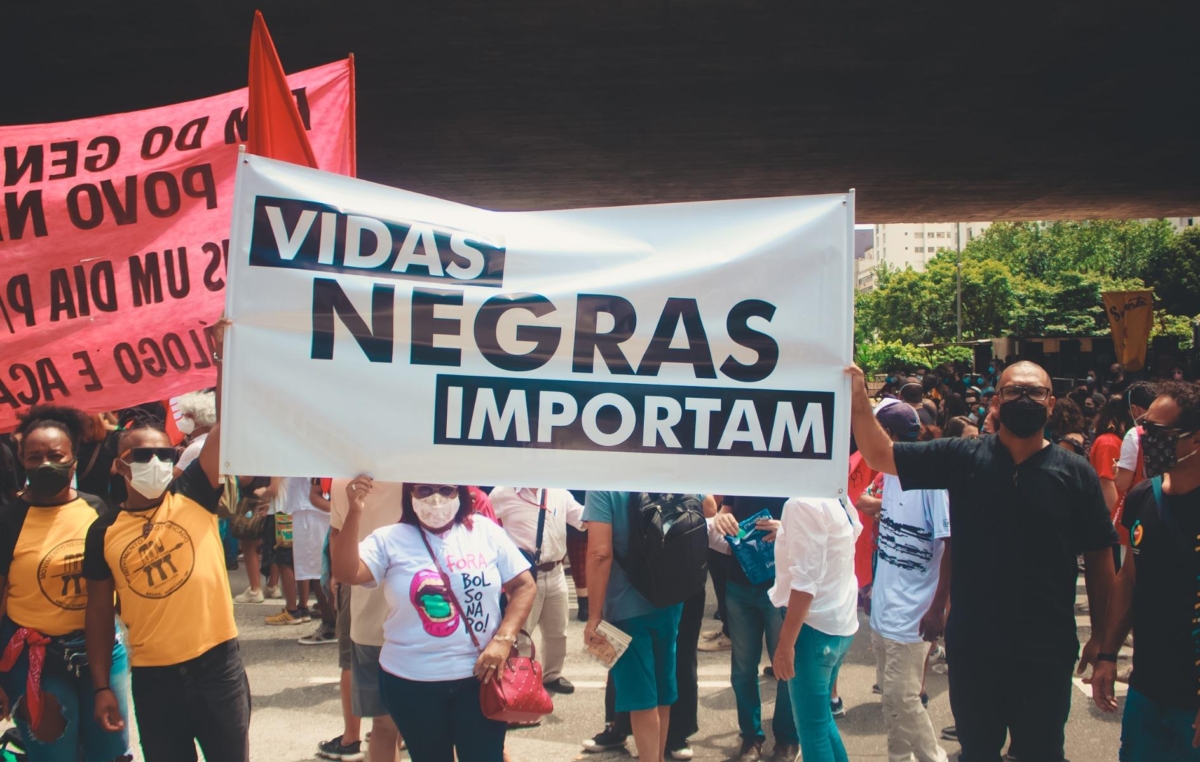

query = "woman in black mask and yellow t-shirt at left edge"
[{"left": 0, "top": 406, "right": 132, "bottom": 762}]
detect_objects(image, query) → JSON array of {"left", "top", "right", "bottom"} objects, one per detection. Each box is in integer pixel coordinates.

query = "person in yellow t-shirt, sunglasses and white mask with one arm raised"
[{"left": 83, "top": 320, "right": 250, "bottom": 762}]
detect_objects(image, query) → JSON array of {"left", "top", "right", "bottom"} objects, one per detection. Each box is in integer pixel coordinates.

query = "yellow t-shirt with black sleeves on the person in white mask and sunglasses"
[{"left": 84, "top": 461, "right": 238, "bottom": 667}]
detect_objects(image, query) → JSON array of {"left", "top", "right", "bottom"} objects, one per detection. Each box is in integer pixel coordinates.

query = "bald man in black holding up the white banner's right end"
[{"left": 847, "top": 362, "right": 1116, "bottom": 762}]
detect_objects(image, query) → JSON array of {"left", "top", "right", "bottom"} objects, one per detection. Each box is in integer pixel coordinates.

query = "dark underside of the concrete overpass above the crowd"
[{"left": 0, "top": 0, "right": 1200, "bottom": 222}]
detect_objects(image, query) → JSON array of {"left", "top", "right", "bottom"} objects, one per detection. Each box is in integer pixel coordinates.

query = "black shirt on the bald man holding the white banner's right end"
[{"left": 893, "top": 434, "right": 1117, "bottom": 661}]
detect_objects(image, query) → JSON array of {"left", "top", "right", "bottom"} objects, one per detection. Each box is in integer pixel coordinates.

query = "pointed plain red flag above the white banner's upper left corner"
[{"left": 246, "top": 11, "right": 317, "bottom": 169}]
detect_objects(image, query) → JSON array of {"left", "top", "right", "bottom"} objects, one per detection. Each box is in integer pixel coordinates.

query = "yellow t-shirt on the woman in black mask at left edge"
[{"left": 0, "top": 493, "right": 107, "bottom": 635}]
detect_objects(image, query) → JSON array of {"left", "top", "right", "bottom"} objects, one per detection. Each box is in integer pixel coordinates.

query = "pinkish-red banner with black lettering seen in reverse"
[{"left": 0, "top": 61, "right": 354, "bottom": 431}]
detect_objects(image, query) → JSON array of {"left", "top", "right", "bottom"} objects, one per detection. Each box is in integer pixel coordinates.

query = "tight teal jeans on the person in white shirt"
[{"left": 787, "top": 624, "right": 854, "bottom": 762}]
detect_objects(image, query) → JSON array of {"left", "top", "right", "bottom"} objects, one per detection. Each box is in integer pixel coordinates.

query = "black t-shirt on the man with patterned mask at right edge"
[{"left": 1121, "top": 479, "right": 1200, "bottom": 712}]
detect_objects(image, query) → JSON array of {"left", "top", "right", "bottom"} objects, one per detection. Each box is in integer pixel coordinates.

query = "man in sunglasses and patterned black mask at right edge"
[{"left": 1092, "top": 382, "right": 1200, "bottom": 762}]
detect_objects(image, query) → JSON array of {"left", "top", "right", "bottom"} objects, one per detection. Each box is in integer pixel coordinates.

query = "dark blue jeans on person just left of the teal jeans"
[{"left": 725, "top": 580, "right": 799, "bottom": 745}]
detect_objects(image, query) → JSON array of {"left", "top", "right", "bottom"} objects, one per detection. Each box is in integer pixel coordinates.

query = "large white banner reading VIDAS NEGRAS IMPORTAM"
[{"left": 221, "top": 155, "right": 854, "bottom": 497}]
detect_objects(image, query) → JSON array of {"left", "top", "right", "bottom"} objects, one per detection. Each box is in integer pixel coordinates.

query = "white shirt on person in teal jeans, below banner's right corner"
[{"left": 770, "top": 498, "right": 863, "bottom": 636}]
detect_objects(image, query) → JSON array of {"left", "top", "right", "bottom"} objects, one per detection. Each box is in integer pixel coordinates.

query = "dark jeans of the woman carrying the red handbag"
[{"left": 379, "top": 668, "right": 509, "bottom": 762}]
